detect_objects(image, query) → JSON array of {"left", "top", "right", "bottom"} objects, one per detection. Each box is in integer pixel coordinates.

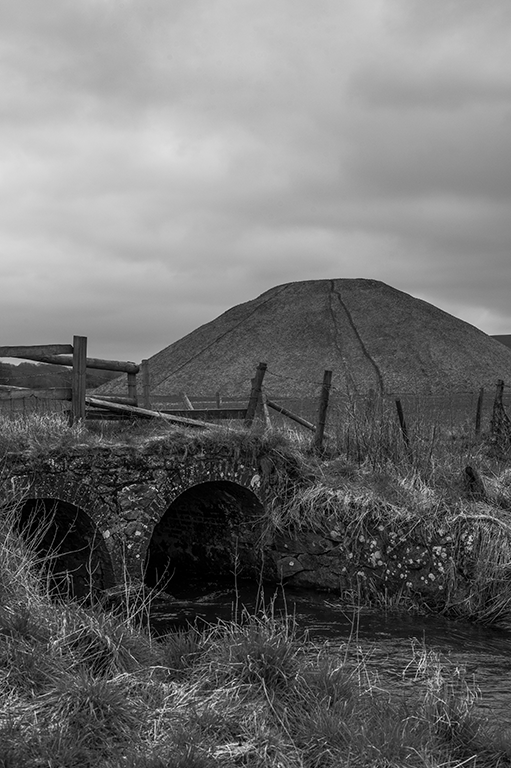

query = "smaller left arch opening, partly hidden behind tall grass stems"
[{"left": 18, "top": 498, "right": 115, "bottom": 600}]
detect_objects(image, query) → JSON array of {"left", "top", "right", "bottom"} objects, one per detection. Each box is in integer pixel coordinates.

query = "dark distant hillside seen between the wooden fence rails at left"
[{"left": 0, "top": 361, "right": 119, "bottom": 389}]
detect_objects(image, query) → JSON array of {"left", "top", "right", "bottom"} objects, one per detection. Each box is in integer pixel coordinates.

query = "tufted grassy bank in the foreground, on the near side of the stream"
[{"left": 0, "top": 515, "right": 511, "bottom": 768}]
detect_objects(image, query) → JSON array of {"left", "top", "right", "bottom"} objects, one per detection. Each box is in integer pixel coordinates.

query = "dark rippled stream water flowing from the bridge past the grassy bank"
[{"left": 152, "top": 582, "right": 511, "bottom": 727}]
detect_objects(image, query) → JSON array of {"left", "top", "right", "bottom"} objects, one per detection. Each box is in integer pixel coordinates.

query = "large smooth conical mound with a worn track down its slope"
[{"left": 101, "top": 279, "right": 511, "bottom": 398}]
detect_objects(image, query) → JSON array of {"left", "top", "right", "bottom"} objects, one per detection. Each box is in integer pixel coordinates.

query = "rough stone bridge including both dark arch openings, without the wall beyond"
[{"left": 1, "top": 441, "right": 284, "bottom": 595}]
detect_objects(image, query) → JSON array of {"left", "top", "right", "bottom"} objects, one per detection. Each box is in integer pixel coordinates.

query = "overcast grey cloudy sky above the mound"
[{"left": 0, "top": 0, "right": 511, "bottom": 362}]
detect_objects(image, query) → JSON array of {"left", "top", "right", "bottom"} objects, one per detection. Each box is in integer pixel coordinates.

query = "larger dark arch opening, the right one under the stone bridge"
[{"left": 145, "top": 480, "right": 264, "bottom": 594}]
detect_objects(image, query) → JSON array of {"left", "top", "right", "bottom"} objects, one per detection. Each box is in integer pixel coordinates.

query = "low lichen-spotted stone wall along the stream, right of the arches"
[{"left": 268, "top": 519, "right": 464, "bottom": 605}]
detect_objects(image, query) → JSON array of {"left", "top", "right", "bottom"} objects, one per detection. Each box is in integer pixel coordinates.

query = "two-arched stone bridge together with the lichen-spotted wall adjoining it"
[{"left": 0, "top": 438, "right": 475, "bottom": 602}]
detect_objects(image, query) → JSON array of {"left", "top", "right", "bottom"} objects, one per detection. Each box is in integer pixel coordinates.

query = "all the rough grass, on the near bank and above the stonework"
[{"left": 0, "top": 413, "right": 511, "bottom": 768}]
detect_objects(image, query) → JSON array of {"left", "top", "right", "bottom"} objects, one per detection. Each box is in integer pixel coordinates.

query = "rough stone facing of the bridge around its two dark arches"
[{"left": 0, "top": 456, "right": 269, "bottom": 585}]
